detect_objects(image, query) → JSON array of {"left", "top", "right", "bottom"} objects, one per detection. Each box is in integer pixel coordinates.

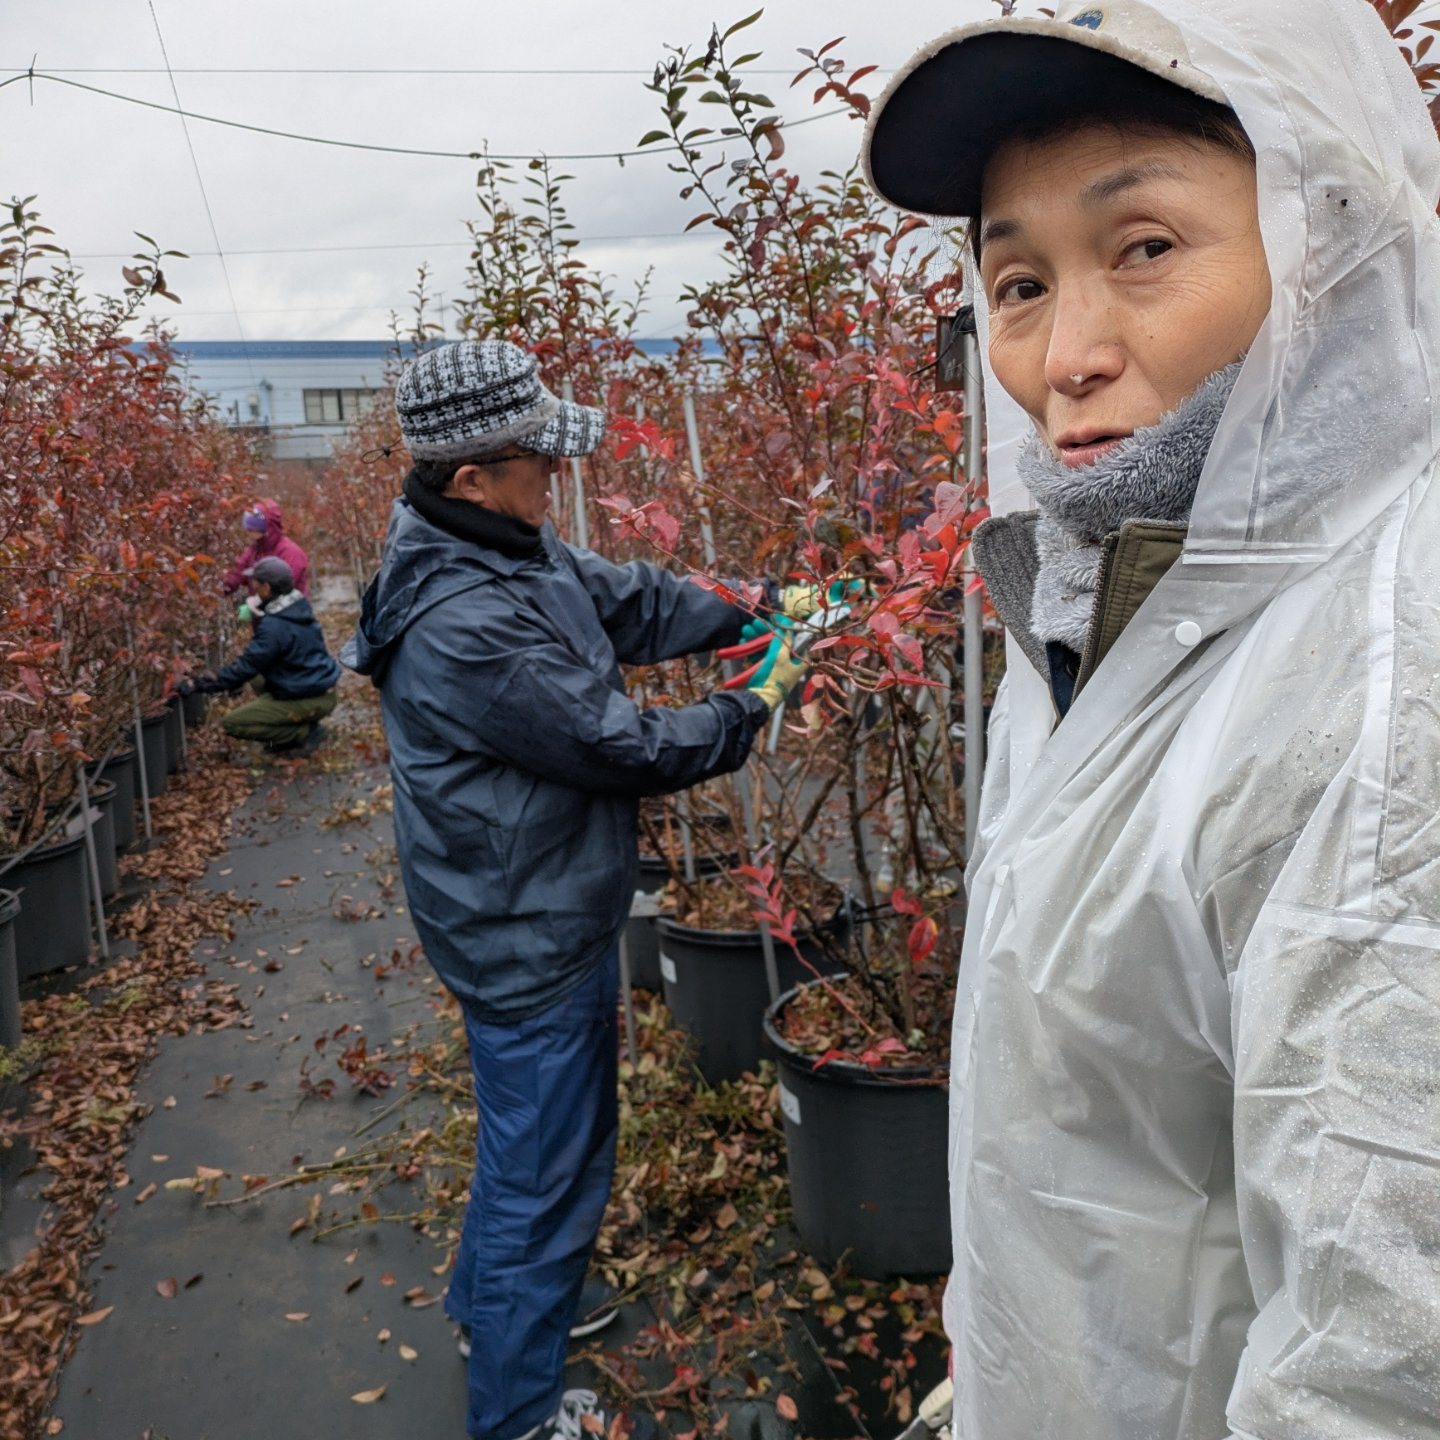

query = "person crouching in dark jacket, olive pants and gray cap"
[{"left": 194, "top": 556, "right": 340, "bottom": 752}]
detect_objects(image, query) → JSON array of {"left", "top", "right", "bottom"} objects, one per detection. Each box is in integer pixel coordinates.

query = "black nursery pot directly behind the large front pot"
[{"left": 657, "top": 914, "right": 841, "bottom": 1084}]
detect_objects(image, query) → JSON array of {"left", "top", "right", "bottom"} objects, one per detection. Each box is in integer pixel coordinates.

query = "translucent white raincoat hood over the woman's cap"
[{"left": 978, "top": 0, "right": 1440, "bottom": 573}]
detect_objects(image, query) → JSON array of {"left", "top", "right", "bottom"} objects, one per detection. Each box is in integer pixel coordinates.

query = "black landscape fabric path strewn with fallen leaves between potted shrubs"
[{"left": 0, "top": 720, "right": 937, "bottom": 1440}]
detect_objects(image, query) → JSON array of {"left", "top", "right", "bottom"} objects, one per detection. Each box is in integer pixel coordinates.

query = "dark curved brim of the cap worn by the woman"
[{"left": 861, "top": 19, "right": 1227, "bottom": 219}]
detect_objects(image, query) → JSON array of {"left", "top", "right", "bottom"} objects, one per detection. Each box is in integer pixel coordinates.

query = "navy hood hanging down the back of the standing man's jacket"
[{"left": 340, "top": 500, "right": 527, "bottom": 684}]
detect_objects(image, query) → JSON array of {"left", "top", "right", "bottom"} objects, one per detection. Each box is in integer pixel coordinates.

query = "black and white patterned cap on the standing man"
[{"left": 395, "top": 340, "right": 605, "bottom": 459}]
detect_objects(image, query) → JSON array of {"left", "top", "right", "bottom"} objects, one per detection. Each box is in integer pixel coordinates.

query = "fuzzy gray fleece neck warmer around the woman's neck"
[{"left": 1017, "top": 360, "right": 1241, "bottom": 651}]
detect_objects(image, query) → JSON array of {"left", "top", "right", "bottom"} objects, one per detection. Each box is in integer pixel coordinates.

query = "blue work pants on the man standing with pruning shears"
[{"left": 445, "top": 949, "right": 619, "bottom": 1440}]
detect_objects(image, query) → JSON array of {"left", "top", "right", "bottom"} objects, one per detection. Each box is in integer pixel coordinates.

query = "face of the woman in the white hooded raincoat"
[{"left": 981, "top": 125, "right": 1270, "bottom": 467}]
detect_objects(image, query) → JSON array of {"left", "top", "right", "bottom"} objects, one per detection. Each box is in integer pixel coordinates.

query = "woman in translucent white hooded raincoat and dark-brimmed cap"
[{"left": 865, "top": 0, "right": 1440, "bottom": 1440}]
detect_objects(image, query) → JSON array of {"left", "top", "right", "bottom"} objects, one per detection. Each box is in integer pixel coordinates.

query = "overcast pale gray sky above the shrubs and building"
[{"left": 0, "top": 0, "right": 1002, "bottom": 340}]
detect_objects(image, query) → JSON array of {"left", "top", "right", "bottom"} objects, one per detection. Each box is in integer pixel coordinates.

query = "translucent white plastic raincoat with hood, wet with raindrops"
[{"left": 946, "top": 0, "right": 1440, "bottom": 1440}]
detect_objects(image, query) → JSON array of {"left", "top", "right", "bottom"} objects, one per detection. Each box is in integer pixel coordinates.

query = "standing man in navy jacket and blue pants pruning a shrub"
[{"left": 341, "top": 341, "right": 804, "bottom": 1440}]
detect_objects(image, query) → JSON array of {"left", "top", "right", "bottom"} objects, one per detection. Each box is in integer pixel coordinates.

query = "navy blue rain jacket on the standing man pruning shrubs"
[{"left": 341, "top": 501, "right": 769, "bottom": 1022}]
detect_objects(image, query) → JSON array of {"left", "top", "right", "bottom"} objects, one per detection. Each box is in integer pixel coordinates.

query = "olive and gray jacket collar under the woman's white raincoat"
[{"left": 971, "top": 510, "right": 1185, "bottom": 705}]
